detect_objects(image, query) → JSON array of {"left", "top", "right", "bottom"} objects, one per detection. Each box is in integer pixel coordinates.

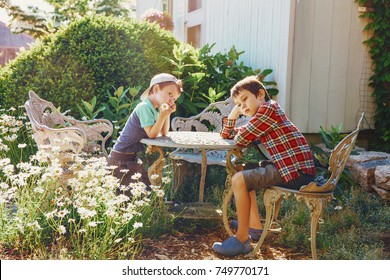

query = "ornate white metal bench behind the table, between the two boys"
[{"left": 170, "top": 97, "right": 249, "bottom": 202}]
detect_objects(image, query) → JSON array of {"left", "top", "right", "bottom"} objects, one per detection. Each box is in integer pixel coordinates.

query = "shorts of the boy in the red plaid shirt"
[{"left": 241, "top": 164, "right": 315, "bottom": 192}]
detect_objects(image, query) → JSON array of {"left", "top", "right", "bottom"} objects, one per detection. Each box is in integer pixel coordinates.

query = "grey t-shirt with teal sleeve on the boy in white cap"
[{"left": 113, "top": 99, "right": 159, "bottom": 153}]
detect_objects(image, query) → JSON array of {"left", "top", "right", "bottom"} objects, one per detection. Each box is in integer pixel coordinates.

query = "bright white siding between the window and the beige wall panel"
[{"left": 203, "top": 0, "right": 291, "bottom": 112}]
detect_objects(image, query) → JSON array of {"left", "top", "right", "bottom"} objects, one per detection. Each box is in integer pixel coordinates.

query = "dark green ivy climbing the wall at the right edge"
[{"left": 355, "top": 0, "right": 390, "bottom": 152}]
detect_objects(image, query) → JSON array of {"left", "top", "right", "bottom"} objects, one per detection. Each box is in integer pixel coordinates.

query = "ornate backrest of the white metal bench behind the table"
[{"left": 171, "top": 97, "right": 249, "bottom": 132}]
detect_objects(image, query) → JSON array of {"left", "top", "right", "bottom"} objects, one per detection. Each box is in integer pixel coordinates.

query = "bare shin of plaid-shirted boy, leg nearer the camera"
[{"left": 232, "top": 172, "right": 251, "bottom": 243}]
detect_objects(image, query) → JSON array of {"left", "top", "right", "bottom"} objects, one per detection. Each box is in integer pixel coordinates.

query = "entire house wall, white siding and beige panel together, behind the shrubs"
[{"left": 137, "top": 0, "right": 375, "bottom": 133}]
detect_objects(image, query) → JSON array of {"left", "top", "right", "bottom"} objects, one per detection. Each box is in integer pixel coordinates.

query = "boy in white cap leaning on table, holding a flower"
[{"left": 108, "top": 73, "right": 182, "bottom": 189}]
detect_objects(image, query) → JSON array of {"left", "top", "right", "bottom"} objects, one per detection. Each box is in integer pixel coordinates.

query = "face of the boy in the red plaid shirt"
[{"left": 233, "top": 89, "right": 265, "bottom": 117}]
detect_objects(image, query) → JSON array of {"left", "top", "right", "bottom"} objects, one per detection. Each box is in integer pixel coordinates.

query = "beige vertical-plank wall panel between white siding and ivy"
[{"left": 290, "top": 0, "right": 375, "bottom": 132}]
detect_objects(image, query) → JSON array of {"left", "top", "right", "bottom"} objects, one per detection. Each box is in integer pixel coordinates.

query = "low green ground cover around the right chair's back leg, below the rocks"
[{"left": 272, "top": 186, "right": 390, "bottom": 260}]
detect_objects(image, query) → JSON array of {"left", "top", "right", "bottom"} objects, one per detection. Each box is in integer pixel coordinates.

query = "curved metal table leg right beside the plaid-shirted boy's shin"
[{"left": 222, "top": 148, "right": 242, "bottom": 236}]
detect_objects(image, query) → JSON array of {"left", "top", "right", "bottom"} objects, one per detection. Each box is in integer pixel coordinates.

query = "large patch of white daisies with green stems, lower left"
[{"left": 0, "top": 109, "right": 170, "bottom": 255}]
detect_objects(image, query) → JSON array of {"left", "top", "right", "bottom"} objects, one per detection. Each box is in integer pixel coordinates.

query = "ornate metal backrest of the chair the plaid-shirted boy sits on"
[{"left": 299, "top": 113, "right": 364, "bottom": 193}]
